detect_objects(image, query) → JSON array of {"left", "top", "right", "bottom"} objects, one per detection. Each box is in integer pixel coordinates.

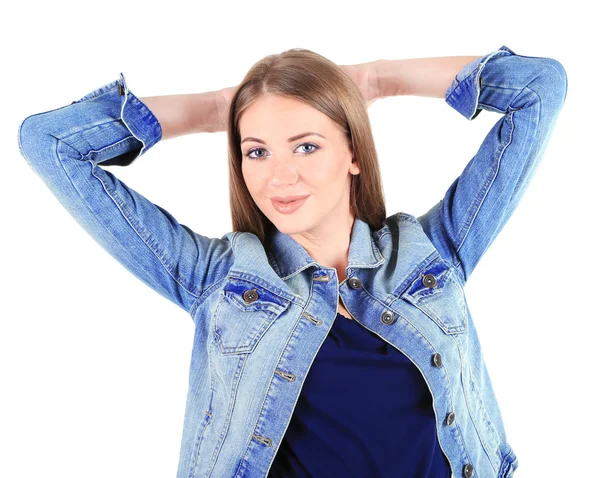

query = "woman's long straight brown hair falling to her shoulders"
[{"left": 227, "top": 48, "right": 386, "bottom": 244}]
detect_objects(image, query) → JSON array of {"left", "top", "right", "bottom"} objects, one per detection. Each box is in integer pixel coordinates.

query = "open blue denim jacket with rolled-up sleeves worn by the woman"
[{"left": 19, "top": 46, "right": 567, "bottom": 478}]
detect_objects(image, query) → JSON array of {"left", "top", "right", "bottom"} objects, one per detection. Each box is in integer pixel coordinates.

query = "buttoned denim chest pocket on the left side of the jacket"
[{"left": 213, "top": 278, "right": 290, "bottom": 355}]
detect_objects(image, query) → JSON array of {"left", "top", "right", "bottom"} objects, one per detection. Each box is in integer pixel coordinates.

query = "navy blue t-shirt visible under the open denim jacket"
[{"left": 268, "top": 313, "right": 452, "bottom": 478}]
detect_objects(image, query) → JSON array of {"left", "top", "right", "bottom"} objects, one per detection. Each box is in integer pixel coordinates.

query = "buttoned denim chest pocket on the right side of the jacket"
[{"left": 402, "top": 259, "right": 467, "bottom": 334}]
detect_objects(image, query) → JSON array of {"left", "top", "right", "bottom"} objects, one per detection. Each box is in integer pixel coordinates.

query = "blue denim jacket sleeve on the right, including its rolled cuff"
[{"left": 417, "top": 46, "right": 567, "bottom": 283}]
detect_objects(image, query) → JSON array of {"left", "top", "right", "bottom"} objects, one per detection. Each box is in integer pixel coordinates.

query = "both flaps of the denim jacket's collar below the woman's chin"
[{"left": 267, "top": 216, "right": 385, "bottom": 280}]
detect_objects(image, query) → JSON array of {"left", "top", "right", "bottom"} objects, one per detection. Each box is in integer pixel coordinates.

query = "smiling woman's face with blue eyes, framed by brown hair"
[{"left": 240, "top": 95, "right": 360, "bottom": 234}]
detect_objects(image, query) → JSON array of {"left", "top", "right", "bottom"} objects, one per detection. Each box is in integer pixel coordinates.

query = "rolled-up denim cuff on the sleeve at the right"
[{"left": 446, "top": 45, "right": 516, "bottom": 121}]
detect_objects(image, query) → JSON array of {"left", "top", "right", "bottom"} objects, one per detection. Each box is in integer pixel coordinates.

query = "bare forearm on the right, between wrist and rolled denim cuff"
[{"left": 373, "top": 55, "right": 483, "bottom": 98}]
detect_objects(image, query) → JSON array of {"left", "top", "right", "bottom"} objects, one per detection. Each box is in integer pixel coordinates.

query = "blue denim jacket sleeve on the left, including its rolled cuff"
[{"left": 19, "top": 73, "right": 235, "bottom": 313}]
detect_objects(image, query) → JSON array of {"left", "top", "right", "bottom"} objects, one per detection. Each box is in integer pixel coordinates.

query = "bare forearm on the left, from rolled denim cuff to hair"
[{"left": 140, "top": 87, "right": 235, "bottom": 141}]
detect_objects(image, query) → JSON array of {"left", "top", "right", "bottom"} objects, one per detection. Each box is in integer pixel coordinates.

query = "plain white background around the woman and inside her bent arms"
[{"left": 0, "top": 0, "right": 600, "bottom": 478}]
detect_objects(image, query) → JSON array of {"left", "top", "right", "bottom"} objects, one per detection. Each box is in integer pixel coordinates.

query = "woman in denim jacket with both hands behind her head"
[{"left": 19, "top": 46, "right": 567, "bottom": 478}]
